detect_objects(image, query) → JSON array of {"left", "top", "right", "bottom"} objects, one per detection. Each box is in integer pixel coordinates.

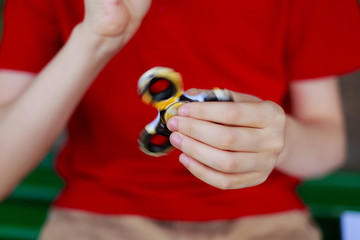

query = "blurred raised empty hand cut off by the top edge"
[{"left": 81, "top": 0, "right": 151, "bottom": 47}]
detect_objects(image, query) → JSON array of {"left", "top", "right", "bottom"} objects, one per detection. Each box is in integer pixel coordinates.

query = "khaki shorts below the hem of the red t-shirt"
[{"left": 39, "top": 208, "right": 321, "bottom": 240}]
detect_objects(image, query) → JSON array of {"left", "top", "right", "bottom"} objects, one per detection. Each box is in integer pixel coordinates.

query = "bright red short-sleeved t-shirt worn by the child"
[{"left": 0, "top": 0, "right": 360, "bottom": 220}]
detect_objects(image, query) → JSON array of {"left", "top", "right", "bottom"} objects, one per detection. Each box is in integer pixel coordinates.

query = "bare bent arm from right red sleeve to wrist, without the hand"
[{"left": 277, "top": 77, "right": 346, "bottom": 178}]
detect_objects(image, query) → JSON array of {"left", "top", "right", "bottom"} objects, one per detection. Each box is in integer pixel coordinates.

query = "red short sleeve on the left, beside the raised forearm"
[{"left": 0, "top": 0, "right": 61, "bottom": 73}]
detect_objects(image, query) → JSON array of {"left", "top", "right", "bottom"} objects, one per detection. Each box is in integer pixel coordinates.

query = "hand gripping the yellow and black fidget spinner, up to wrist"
[{"left": 167, "top": 92, "right": 286, "bottom": 189}]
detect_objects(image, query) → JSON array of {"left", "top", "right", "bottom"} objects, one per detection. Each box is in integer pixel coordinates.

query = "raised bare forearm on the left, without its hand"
[{"left": 0, "top": 24, "right": 118, "bottom": 201}]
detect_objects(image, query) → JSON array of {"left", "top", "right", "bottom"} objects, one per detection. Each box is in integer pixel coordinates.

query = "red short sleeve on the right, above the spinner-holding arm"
[{"left": 285, "top": 0, "right": 360, "bottom": 80}]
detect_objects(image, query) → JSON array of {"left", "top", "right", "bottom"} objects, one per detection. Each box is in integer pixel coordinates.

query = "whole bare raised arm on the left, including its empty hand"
[{"left": 0, "top": 0, "right": 150, "bottom": 200}]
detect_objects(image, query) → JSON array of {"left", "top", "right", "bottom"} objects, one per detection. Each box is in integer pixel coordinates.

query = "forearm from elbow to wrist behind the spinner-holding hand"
[{"left": 276, "top": 116, "right": 346, "bottom": 178}]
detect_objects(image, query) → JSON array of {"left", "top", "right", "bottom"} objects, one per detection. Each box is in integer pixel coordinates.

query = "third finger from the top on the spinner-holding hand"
[{"left": 170, "top": 132, "right": 267, "bottom": 173}]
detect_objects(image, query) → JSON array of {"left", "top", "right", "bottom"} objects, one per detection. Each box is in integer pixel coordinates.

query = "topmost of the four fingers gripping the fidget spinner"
[{"left": 178, "top": 101, "right": 284, "bottom": 128}]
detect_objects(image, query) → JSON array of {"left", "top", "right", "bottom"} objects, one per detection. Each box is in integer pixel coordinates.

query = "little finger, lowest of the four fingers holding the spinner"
[{"left": 179, "top": 154, "right": 266, "bottom": 190}]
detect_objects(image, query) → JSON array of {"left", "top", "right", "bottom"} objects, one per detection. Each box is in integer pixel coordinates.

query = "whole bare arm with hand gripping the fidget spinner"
[{"left": 168, "top": 78, "right": 345, "bottom": 189}]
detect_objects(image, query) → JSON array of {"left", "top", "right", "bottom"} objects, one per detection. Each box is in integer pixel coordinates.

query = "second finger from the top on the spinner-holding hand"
[{"left": 167, "top": 116, "right": 268, "bottom": 152}]
